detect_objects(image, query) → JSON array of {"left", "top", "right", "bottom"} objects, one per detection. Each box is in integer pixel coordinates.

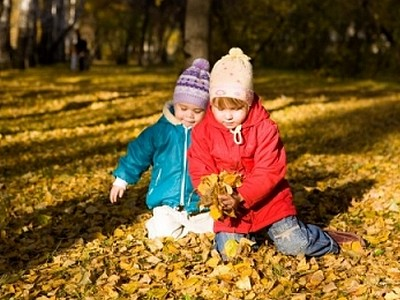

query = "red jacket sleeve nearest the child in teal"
[{"left": 188, "top": 125, "right": 218, "bottom": 188}]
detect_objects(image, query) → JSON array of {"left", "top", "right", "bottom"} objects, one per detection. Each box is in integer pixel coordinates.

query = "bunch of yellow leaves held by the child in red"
[{"left": 197, "top": 171, "right": 242, "bottom": 220}]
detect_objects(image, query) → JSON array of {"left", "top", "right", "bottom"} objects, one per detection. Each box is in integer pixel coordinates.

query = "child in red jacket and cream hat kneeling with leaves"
[{"left": 188, "top": 48, "right": 360, "bottom": 258}]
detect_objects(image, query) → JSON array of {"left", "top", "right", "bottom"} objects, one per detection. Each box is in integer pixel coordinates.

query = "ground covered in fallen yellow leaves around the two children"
[{"left": 0, "top": 65, "right": 400, "bottom": 300}]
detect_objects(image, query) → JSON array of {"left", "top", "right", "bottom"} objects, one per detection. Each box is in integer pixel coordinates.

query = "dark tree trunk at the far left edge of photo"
[{"left": 0, "top": 0, "right": 12, "bottom": 70}]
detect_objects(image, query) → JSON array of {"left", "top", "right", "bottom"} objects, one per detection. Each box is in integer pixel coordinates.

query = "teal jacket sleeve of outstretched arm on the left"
[{"left": 113, "top": 126, "right": 155, "bottom": 184}]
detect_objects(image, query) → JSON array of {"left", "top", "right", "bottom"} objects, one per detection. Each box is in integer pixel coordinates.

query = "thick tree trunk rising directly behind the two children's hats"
[{"left": 184, "top": 0, "right": 211, "bottom": 66}]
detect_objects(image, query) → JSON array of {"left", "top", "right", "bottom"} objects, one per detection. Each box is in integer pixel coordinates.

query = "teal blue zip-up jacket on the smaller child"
[{"left": 113, "top": 102, "right": 199, "bottom": 213}]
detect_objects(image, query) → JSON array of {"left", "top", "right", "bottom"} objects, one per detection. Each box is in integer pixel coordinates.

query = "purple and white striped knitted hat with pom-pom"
[{"left": 173, "top": 58, "right": 210, "bottom": 109}]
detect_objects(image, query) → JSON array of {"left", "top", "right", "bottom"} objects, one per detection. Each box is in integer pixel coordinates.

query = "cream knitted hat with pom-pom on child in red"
[{"left": 210, "top": 48, "right": 254, "bottom": 105}]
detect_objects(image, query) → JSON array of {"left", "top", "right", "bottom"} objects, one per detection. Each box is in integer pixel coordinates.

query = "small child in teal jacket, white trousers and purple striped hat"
[{"left": 110, "top": 58, "right": 213, "bottom": 239}]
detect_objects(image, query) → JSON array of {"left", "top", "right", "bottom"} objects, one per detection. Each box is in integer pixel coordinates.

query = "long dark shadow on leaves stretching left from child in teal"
[{"left": 0, "top": 186, "right": 148, "bottom": 275}]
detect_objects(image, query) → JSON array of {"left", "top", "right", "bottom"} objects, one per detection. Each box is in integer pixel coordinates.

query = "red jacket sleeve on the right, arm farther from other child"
[{"left": 238, "top": 120, "right": 286, "bottom": 208}]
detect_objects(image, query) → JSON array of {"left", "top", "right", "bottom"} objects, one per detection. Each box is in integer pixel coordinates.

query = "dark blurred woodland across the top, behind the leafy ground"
[{"left": 0, "top": 0, "right": 400, "bottom": 77}]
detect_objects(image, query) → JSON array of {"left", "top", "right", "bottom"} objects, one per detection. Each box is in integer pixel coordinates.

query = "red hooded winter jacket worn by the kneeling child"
[{"left": 188, "top": 97, "right": 296, "bottom": 233}]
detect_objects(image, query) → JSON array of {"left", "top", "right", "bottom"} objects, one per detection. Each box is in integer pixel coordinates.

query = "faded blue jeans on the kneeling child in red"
[{"left": 214, "top": 216, "right": 339, "bottom": 259}]
